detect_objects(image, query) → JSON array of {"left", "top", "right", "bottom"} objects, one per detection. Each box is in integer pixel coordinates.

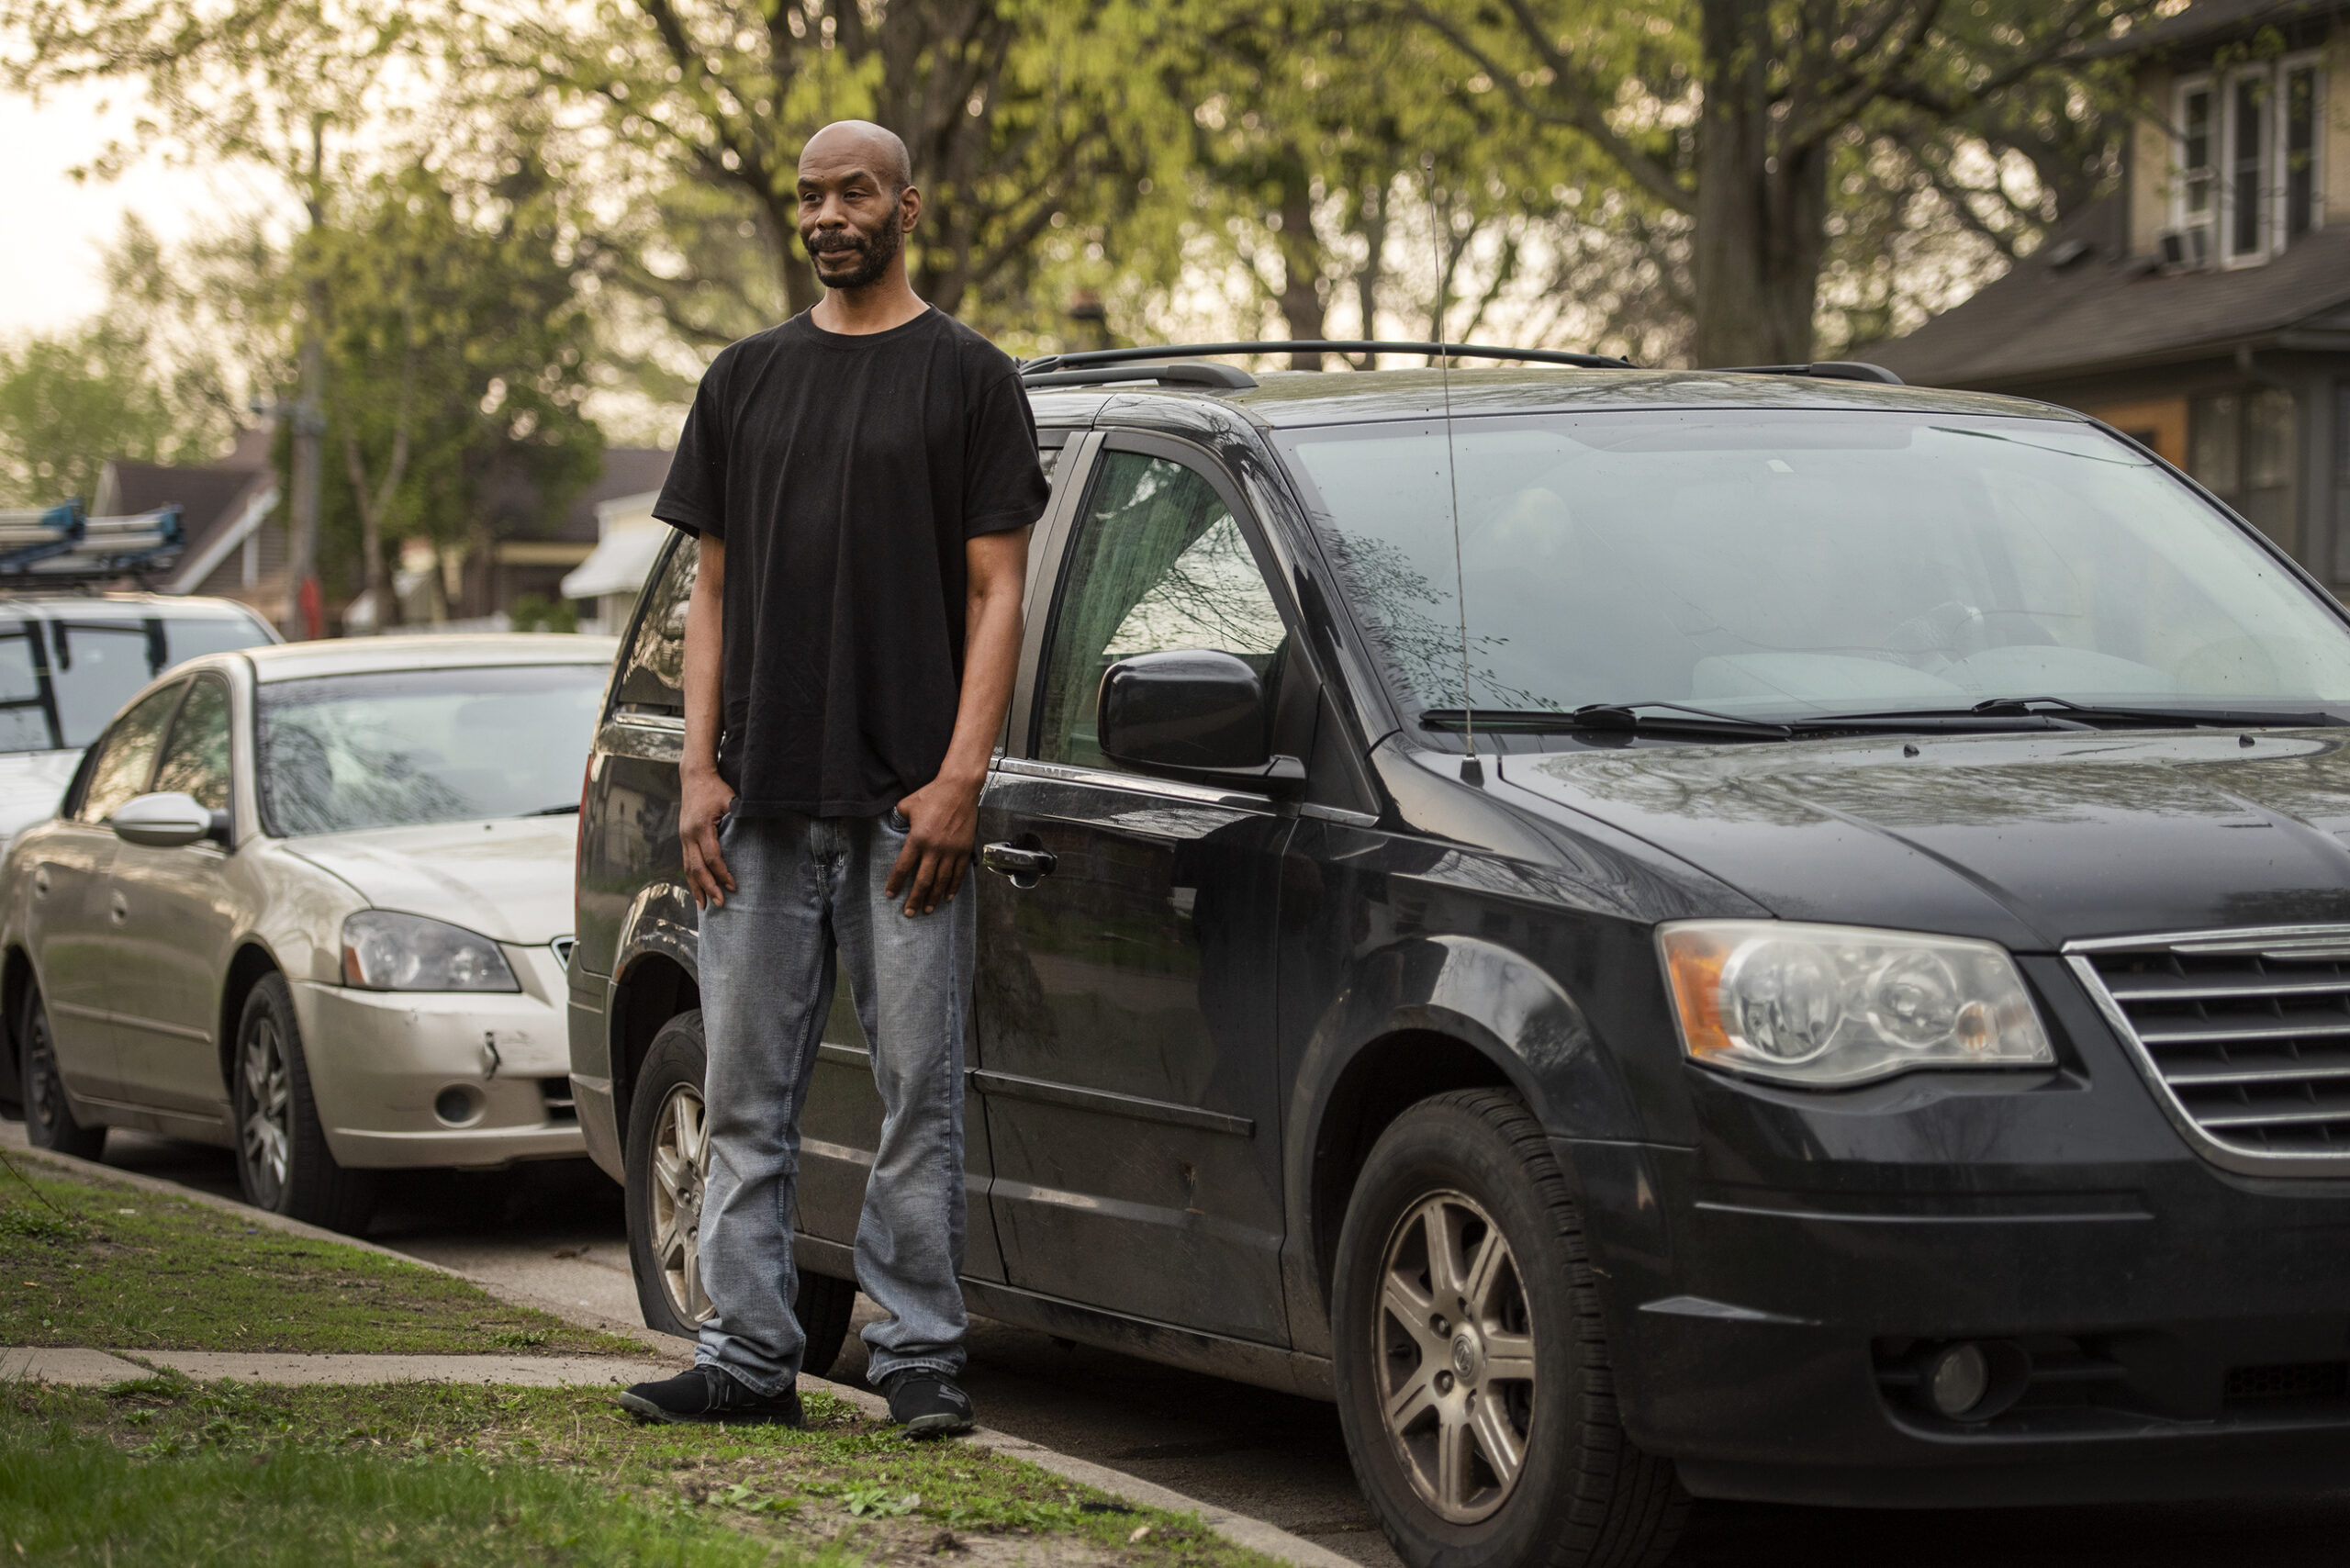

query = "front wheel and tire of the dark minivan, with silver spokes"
[{"left": 1330, "top": 1089, "right": 1687, "bottom": 1568}]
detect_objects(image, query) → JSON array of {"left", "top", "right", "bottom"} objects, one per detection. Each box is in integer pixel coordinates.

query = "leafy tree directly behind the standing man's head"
[{"left": 467, "top": 0, "right": 1158, "bottom": 336}]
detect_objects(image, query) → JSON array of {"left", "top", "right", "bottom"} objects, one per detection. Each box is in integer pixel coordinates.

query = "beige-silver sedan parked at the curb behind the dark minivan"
[{"left": 0, "top": 637, "right": 613, "bottom": 1229}]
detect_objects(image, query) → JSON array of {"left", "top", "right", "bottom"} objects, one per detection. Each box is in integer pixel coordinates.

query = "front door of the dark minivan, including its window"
[{"left": 973, "top": 437, "right": 1295, "bottom": 1345}]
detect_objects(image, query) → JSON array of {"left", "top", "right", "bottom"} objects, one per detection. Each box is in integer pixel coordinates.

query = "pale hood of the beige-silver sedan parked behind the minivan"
[{"left": 286, "top": 816, "right": 578, "bottom": 947}]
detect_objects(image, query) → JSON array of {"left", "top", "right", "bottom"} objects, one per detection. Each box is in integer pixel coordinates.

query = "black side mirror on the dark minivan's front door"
[{"left": 1095, "top": 649, "right": 1304, "bottom": 790}]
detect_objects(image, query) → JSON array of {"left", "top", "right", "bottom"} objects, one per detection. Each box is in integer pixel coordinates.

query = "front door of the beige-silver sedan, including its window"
[{"left": 108, "top": 672, "right": 240, "bottom": 1119}]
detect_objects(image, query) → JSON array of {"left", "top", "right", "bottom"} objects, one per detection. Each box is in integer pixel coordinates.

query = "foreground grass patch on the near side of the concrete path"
[{"left": 0, "top": 1378, "right": 1271, "bottom": 1568}]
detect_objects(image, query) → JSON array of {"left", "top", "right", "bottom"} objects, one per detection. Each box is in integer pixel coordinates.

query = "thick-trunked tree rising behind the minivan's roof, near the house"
[{"left": 1398, "top": 0, "right": 2155, "bottom": 364}]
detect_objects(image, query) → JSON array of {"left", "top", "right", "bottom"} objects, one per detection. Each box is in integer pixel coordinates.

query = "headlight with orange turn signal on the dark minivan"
[{"left": 1657, "top": 919, "right": 2056, "bottom": 1086}]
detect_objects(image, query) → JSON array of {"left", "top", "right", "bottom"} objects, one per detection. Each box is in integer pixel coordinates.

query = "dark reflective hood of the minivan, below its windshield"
[{"left": 1502, "top": 729, "right": 2350, "bottom": 950}]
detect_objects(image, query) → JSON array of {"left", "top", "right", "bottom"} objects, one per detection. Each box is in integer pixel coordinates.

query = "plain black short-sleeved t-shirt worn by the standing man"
[{"left": 654, "top": 310, "right": 1048, "bottom": 816}]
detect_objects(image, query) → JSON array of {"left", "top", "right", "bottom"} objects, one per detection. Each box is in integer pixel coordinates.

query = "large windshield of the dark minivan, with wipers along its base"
[{"left": 1283, "top": 409, "right": 2350, "bottom": 720}]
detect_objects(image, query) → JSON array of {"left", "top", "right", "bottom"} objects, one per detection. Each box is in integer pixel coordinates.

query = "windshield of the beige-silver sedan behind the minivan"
[{"left": 261, "top": 666, "right": 604, "bottom": 837}]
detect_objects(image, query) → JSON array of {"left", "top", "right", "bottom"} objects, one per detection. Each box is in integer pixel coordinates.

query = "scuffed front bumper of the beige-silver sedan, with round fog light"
[{"left": 294, "top": 976, "right": 585, "bottom": 1169}]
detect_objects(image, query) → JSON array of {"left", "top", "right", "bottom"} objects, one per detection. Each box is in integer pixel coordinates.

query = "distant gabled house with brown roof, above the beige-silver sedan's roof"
[{"left": 89, "top": 428, "right": 286, "bottom": 621}]
